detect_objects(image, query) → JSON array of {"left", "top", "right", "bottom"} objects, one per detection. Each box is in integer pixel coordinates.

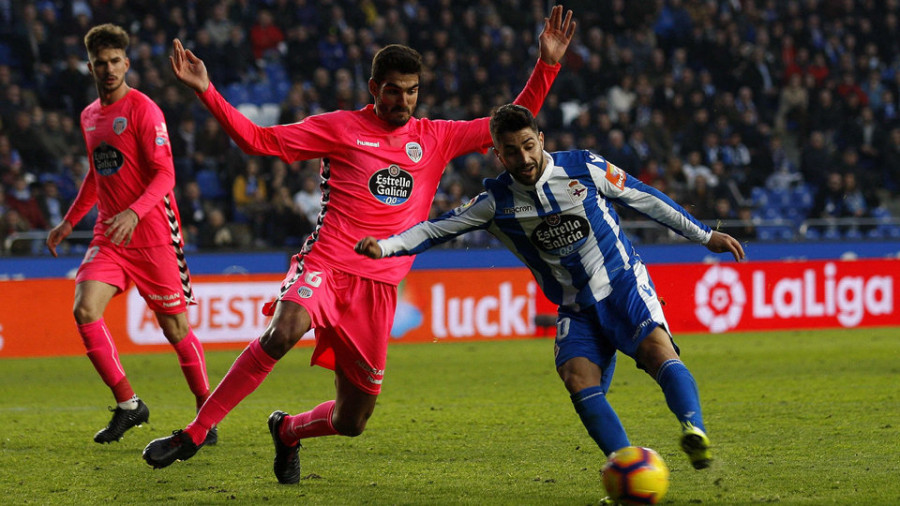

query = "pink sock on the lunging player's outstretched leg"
[{"left": 184, "top": 339, "right": 278, "bottom": 445}]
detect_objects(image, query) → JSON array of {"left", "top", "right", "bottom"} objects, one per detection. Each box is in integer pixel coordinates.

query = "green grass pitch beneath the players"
[{"left": 0, "top": 328, "right": 900, "bottom": 505}]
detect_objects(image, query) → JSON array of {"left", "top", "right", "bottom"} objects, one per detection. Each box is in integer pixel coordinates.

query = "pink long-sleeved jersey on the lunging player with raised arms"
[{"left": 199, "top": 60, "right": 559, "bottom": 285}]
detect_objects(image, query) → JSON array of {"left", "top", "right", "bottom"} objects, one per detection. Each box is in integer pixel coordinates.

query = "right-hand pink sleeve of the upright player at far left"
[{"left": 128, "top": 101, "right": 175, "bottom": 218}]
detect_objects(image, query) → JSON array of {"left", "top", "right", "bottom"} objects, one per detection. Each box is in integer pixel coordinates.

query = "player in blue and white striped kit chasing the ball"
[{"left": 356, "top": 104, "right": 744, "bottom": 469}]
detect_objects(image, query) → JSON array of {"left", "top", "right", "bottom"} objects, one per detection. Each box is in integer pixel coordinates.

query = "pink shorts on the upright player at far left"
[{"left": 75, "top": 238, "right": 195, "bottom": 314}]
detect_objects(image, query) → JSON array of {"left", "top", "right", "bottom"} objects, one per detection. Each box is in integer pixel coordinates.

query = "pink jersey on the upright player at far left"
[{"left": 65, "top": 89, "right": 181, "bottom": 248}]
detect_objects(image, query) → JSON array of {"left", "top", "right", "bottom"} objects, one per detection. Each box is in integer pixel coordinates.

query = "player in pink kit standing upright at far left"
[{"left": 47, "top": 24, "right": 218, "bottom": 444}]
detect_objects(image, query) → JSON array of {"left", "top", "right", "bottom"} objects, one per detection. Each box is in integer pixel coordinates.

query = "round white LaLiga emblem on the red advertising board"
[{"left": 694, "top": 265, "right": 747, "bottom": 332}]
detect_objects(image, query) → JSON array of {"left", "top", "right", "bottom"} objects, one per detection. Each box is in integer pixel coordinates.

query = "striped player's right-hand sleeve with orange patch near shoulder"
[{"left": 587, "top": 153, "right": 712, "bottom": 244}]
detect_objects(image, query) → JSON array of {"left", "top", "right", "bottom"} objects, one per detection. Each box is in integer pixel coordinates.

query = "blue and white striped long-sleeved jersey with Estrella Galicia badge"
[{"left": 378, "top": 151, "right": 712, "bottom": 310}]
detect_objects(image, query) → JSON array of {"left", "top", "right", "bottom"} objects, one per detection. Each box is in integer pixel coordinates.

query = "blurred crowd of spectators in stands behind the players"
[{"left": 0, "top": 0, "right": 900, "bottom": 253}]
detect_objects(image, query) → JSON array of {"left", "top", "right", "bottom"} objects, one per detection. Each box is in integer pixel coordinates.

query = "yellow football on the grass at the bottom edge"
[{"left": 601, "top": 446, "right": 669, "bottom": 504}]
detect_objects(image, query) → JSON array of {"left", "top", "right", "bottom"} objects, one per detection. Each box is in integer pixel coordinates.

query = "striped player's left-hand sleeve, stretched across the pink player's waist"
[{"left": 378, "top": 192, "right": 496, "bottom": 257}]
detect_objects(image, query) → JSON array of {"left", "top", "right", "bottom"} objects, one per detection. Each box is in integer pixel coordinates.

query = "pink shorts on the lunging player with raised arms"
[{"left": 269, "top": 255, "right": 397, "bottom": 395}]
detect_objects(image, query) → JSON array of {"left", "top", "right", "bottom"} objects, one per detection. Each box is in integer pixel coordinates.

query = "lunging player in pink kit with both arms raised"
[{"left": 143, "top": 6, "right": 575, "bottom": 483}]
